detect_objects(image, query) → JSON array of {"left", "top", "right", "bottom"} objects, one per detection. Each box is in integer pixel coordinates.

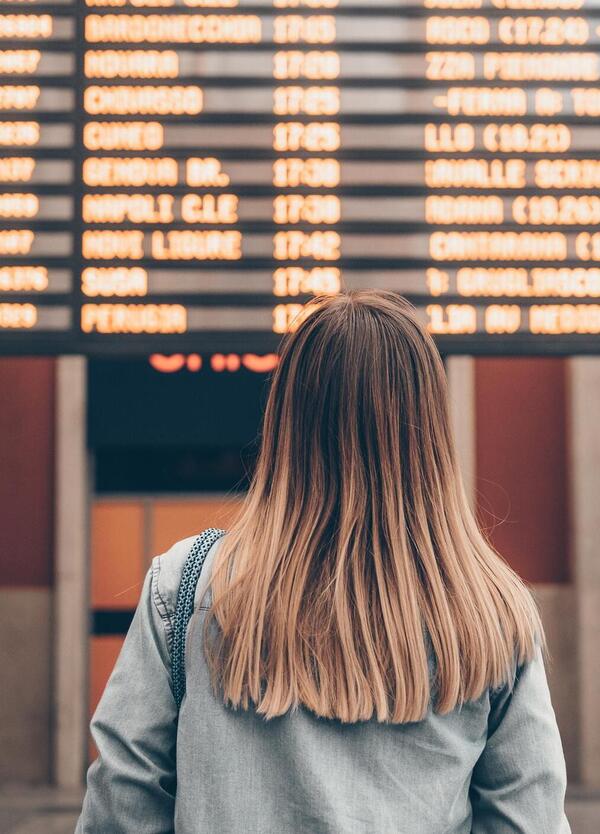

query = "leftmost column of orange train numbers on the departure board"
[{"left": 0, "top": 0, "right": 77, "bottom": 344}]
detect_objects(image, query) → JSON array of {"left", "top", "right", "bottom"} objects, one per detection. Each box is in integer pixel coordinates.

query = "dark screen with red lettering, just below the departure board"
[{"left": 87, "top": 354, "right": 270, "bottom": 494}]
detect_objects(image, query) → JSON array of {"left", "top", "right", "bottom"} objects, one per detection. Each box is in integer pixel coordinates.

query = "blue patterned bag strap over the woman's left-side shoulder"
[{"left": 171, "top": 527, "right": 226, "bottom": 710}]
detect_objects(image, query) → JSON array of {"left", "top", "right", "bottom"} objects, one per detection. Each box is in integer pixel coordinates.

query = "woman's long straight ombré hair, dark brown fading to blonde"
[{"left": 205, "top": 290, "right": 546, "bottom": 723}]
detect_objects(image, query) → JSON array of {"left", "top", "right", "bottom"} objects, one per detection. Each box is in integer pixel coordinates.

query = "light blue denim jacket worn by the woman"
[{"left": 76, "top": 537, "right": 570, "bottom": 834}]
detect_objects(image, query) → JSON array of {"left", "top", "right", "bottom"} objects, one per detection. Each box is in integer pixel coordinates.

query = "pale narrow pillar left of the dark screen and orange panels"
[{"left": 53, "top": 356, "right": 90, "bottom": 788}]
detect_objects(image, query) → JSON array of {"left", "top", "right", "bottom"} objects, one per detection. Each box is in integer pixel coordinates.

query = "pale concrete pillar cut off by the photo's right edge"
[{"left": 569, "top": 356, "right": 600, "bottom": 788}]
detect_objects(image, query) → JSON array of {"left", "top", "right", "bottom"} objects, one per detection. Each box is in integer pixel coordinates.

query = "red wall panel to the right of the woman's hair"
[{"left": 475, "top": 357, "right": 569, "bottom": 582}]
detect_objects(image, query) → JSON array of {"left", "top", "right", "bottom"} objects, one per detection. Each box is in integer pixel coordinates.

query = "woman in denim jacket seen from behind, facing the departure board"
[{"left": 77, "top": 291, "right": 570, "bottom": 834}]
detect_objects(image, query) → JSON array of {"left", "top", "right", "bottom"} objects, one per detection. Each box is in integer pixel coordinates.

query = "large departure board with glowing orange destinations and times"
[{"left": 0, "top": 0, "right": 600, "bottom": 355}]
